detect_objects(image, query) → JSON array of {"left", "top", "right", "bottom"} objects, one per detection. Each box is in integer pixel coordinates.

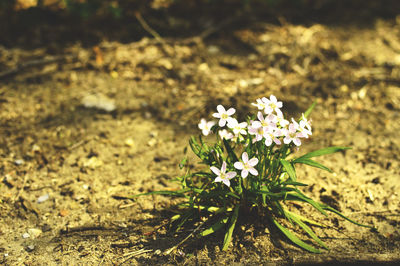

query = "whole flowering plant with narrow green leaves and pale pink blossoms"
[{"left": 136, "top": 95, "right": 369, "bottom": 253}]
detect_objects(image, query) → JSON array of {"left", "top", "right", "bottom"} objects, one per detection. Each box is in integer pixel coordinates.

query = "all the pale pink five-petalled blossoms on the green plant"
[{"left": 199, "top": 95, "right": 312, "bottom": 186}]
